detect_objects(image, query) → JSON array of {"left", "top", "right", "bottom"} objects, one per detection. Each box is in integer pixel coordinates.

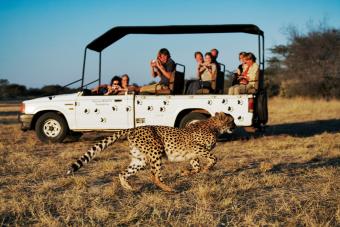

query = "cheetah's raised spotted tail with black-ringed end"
[{"left": 66, "top": 130, "right": 129, "bottom": 175}]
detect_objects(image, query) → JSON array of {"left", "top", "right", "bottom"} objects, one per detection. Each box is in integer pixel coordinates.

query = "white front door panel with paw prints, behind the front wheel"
[{"left": 75, "top": 95, "right": 134, "bottom": 130}]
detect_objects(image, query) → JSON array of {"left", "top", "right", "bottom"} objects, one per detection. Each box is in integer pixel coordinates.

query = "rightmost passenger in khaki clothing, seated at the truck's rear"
[{"left": 228, "top": 53, "right": 259, "bottom": 95}]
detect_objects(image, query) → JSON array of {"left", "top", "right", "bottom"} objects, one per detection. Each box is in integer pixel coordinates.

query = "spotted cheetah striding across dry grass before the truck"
[{"left": 67, "top": 112, "right": 235, "bottom": 192}]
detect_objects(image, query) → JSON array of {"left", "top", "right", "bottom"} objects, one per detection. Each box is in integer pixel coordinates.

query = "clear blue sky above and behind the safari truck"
[{"left": 0, "top": 0, "right": 340, "bottom": 88}]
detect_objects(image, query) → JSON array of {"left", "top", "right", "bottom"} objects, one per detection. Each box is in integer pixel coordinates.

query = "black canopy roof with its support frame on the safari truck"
[{"left": 66, "top": 24, "right": 264, "bottom": 91}]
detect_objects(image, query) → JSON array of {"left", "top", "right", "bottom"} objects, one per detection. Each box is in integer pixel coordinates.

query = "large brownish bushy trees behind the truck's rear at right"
[{"left": 266, "top": 23, "right": 340, "bottom": 99}]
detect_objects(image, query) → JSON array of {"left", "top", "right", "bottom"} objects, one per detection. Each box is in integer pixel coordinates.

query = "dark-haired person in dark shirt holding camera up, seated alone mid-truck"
[{"left": 140, "top": 48, "right": 176, "bottom": 93}]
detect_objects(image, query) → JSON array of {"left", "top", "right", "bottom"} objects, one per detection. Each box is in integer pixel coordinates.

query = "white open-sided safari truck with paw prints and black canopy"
[{"left": 19, "top": 24, "right": 268, "bottom": 142}]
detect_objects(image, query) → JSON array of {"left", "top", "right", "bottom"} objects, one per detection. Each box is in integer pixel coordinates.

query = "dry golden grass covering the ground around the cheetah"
[{"left": 0, "top": 98, "right": 340, "bottom": 226}]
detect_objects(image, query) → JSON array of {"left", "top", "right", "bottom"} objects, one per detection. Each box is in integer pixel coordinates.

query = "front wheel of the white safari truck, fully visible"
[{"left": 35, "top": 112, "right": 69, "bottom": 143}]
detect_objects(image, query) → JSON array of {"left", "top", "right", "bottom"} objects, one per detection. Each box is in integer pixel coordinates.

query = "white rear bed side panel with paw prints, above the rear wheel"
[{"left": 135, "top": 95, "right": 253, "bottom": 126}]
